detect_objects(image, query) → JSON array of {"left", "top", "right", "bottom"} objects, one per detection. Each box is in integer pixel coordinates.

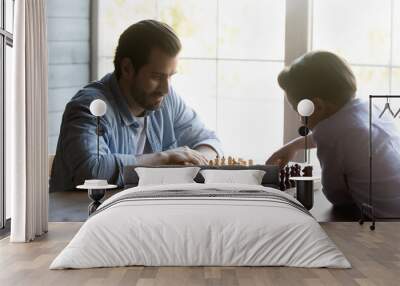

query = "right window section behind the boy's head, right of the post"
[{"left": 312, "top": 0, "right": 400, "bottom": 128}]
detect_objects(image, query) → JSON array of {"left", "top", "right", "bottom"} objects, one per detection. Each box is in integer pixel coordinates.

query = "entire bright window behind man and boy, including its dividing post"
[{"left": 74, "top": 0, "right": 400, "bottom": 172}]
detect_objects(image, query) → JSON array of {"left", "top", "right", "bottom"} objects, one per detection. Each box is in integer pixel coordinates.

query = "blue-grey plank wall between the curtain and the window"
[{"left": 47, "top": 0, "right": 90, "bottom": 154}]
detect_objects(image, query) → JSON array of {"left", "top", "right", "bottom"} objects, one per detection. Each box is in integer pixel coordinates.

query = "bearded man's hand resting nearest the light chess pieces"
[{"left": 161, "top": 146, "right": 208, "bottom": 165}]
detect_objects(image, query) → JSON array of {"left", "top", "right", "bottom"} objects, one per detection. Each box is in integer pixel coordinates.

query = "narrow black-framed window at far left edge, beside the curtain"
[{"left": 0, "top": 0, "right": 14, "bottom": 228}]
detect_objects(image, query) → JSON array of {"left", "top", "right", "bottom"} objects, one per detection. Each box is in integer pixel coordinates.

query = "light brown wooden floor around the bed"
[{"left": 0, "top": 222, "right": 400, "bottom": 286}]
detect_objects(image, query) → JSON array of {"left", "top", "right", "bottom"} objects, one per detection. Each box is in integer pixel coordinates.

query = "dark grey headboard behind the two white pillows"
[{"left": 123, "top": 165, "right": 279, "bottom": 189}]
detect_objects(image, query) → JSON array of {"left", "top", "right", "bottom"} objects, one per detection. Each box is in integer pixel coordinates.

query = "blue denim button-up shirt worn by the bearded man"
[{"left": 50, "top": 73, "right": 222, "bottom": 191}]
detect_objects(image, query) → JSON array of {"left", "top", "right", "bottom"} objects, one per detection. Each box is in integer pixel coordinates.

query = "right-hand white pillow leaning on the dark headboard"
[{"left": 200, "top": 169, "right": 265, "bottom": 185}]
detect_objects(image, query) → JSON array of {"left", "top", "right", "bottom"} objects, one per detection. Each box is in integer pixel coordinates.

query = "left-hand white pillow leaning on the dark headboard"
[{"left": 135, "top": 167, "right": 200, "bottom": 186}]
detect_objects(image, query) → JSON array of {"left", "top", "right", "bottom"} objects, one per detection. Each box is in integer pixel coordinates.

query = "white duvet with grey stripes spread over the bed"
[{"left": 50, "top": 183, "right": 351, "bottom": 269}]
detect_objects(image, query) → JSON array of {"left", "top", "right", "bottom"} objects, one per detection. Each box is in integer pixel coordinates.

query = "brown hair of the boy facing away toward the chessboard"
[{"left": 278, "top": 51, "right": 357, "bottom": 106}]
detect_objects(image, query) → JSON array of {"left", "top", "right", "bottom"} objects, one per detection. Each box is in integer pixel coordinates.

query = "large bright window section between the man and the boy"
[{"left": 96, "top": 0, "right": 285, "bottom": 163}]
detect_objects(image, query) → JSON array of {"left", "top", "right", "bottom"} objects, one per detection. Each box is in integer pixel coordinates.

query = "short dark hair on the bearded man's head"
[{"left": 114, "top": 20, "right": 181, "bottom": 79}]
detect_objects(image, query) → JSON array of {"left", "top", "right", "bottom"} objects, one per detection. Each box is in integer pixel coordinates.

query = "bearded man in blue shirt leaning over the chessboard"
[{"left": 50, "top": 20, "right": 222, "bottom": 191}]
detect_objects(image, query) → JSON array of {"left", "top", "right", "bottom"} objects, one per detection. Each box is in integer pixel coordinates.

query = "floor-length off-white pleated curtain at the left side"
[{"left": 6, "top": 0, "right": 48, "bottom": 242}]
